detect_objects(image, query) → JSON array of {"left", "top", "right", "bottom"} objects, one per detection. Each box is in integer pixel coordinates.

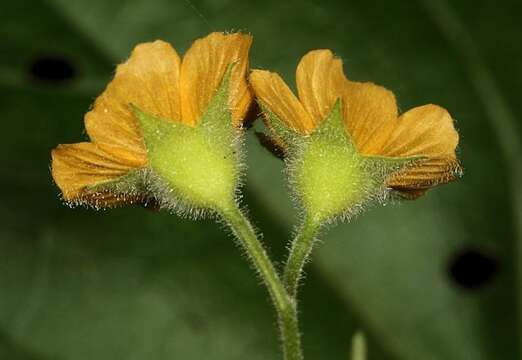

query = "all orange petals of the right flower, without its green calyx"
[{"left": 250, "top": 50, "right": 460, "bottom": 198}]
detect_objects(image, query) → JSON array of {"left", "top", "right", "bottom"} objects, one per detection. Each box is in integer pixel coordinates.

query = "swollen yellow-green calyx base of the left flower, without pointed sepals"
[{"left": 149, "top": 129, "right": 238, "bottom": 208}]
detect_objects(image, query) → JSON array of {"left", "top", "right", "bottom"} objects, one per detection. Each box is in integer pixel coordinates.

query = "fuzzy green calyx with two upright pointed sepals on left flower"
[{"left": 133, "top": 69, "right": 241, "bottom": 214}]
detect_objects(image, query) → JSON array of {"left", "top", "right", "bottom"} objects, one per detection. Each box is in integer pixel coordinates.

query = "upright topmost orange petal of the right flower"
[{"left": 296, "top": 50, "right": 346, "bottom": 124}]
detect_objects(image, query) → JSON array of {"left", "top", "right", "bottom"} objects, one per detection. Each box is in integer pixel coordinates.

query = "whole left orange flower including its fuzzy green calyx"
[{"left": 52, "top": 33, "right": 252, "bottom": 212}]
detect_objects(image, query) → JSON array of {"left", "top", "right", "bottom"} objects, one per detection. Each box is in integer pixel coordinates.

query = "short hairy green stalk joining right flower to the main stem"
[{"left": 283, "top": 217, "right": 320, "bottom": 299}]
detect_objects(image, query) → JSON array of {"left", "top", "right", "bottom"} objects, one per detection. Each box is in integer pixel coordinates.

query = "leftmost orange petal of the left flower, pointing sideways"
[{"left": 52, "top": 142, "right": 143, "bottom": 203}]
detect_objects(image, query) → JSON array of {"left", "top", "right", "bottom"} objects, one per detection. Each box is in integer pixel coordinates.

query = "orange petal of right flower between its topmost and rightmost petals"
[{"left": 343, "top": 81, "right": 398, "bottom": 155}]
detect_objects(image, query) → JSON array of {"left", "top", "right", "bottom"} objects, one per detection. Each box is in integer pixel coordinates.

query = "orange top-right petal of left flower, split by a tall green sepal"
[{"left": 181, "top": 32, "right": 252, "bottom": 125}]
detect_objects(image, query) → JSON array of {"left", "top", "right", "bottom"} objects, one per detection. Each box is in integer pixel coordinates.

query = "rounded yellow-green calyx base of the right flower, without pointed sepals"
[{"left": 294, "top": 141, "right": 372, "bottom": 222}]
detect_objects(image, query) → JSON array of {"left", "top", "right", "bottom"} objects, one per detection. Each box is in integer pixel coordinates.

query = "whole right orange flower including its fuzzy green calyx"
[{"left": 249, "top": 50, "right": 460, "bottom": 222}]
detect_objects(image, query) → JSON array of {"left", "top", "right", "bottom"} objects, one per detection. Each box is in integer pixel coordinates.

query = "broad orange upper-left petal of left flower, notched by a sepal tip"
[{"left": 85, "top": 40, "right": 181, "bottom": 154}]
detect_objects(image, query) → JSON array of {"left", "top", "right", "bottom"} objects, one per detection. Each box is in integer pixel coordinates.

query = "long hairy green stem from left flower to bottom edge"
[{"left": 221, "top": 206, "right": 303, "bottom": 360}]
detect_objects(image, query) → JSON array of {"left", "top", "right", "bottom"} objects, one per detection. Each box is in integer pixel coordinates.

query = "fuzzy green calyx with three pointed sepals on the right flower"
[{"left": 267, "top": 100, "right": 418, "bottom": 224}]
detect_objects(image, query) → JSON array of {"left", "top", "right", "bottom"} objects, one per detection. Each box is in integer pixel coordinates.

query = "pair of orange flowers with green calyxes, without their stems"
[{"left": 52, "top": 33, "right": 460, "bottom": 220}]
